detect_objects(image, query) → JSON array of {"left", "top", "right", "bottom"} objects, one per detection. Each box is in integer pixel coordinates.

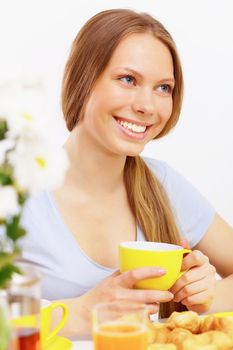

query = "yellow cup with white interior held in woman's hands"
[{"left": 119, "top": 241, "right": 191, "bottom": 290}]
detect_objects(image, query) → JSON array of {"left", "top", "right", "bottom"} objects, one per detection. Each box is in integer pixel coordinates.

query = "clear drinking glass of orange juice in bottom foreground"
[{"left": 92, "top": 301, "right": 149, "bottom": 350}]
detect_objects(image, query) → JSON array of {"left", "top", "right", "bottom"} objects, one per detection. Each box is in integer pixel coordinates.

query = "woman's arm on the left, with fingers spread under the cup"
[{"left": 52, "top": 267, "right": 173, "bottom": 337}]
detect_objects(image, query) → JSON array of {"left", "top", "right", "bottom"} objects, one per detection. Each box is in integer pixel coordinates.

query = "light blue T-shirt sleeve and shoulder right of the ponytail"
[{"left": 145, "top": 159, "right": 215, "bottom": 247}]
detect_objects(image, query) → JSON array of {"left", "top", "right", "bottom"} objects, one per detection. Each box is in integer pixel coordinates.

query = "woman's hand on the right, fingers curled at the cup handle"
[{"left": 170, "top": 250, "right": 216, "bottom": 313}]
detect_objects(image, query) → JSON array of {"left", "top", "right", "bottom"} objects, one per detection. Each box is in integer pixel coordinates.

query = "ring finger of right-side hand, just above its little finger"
[{"left": 173, "top": 277, "right": 214, "bottom": 303}]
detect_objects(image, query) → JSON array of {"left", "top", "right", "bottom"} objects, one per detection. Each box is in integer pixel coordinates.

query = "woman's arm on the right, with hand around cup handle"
[{"left": 171, "top": 215, "right": 233, "bottom": 313}]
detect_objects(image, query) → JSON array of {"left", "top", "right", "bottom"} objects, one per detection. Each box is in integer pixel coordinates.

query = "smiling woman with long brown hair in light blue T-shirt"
[{"left": 22, "top": 9, "right": 233, "bottom": 334}]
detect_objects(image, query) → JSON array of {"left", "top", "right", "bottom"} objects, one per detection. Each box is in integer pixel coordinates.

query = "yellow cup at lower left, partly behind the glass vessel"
[{"left": 13, "top": 302, "right": 68, "bottom": 347}]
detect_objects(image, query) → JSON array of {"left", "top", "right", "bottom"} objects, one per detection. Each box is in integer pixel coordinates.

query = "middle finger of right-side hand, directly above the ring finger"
[{"left": 169, "top": 263, "right": 215, "bottom": 294}]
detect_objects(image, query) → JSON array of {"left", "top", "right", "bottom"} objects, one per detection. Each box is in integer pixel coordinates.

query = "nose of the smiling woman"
[{"left": 132, "top": 89, "right": 155, "bottom": 116}]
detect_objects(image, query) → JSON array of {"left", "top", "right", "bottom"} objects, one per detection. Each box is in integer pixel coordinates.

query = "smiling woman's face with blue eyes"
[{"left": 77, "top": 34, "right": 175, "bottom": 156}]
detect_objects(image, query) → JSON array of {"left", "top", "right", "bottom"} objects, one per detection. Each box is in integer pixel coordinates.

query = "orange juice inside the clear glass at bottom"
[{"left": 94, "top": 323, "right": 147, "bottom": 350}]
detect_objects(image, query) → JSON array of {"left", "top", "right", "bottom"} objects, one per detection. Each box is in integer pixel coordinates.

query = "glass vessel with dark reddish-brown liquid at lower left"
[{"left": 8, "top": 263, "right": 42, "bottom": 350}]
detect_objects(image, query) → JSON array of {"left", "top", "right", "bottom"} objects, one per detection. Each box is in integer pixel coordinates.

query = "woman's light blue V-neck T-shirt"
[{"left": 18, "top": 158, "right": 215, "bottom": 300}]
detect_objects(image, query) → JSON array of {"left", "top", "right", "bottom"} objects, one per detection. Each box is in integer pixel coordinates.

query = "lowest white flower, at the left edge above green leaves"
[{"left": 0, "top": 186, "right": 20, "bottom": 219}]
